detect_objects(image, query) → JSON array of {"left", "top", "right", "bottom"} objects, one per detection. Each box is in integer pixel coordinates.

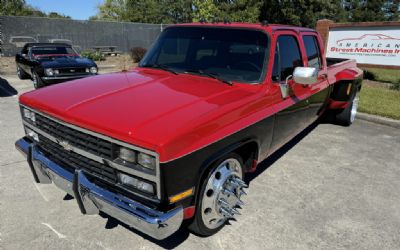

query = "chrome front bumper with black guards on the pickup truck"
[{"left": 15, "top": 138, "right": 183, "bottom": 240}]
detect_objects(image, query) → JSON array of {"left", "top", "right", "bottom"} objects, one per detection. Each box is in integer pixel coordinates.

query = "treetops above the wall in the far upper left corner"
[{"left": 0, "top": 0, "right": 71, "bottom": 18}]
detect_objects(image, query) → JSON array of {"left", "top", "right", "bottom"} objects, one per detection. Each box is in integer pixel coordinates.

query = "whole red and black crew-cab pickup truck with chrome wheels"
[{"left": 16, "top": 23, "right": 362, "bottom": 239}]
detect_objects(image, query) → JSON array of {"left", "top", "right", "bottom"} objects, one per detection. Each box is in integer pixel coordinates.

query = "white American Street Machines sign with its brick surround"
[{"left": 317, "top": 20, "right": 400, "bottom": 69}]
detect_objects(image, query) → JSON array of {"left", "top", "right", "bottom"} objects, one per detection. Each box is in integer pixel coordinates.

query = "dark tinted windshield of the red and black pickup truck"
[{"left": 140, "top": 27, "right": 268, "bottom": 83}]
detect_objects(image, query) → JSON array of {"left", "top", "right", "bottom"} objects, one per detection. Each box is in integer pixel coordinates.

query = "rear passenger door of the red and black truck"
[{"left": 301, "top": 32, "right": 329, "bottom": 123}]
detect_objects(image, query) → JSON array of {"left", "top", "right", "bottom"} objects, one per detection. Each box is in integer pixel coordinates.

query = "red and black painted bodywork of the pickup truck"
[{"left": 20, "top": 23, "right": 362, "bottom": 214}]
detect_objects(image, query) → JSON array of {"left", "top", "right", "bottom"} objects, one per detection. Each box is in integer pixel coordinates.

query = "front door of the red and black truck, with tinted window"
[{"left": 270, "top": 31, "right": 309, "bottom": 150}]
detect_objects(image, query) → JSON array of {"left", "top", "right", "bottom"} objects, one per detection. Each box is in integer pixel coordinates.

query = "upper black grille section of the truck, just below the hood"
[{"left": 36, "top": 114, "right": 116, "bottom": 160}]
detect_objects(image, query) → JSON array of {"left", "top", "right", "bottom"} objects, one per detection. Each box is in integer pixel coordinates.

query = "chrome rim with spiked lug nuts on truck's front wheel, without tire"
[{"left": 201, "top": 158, "right": 247, "bottom": 229}]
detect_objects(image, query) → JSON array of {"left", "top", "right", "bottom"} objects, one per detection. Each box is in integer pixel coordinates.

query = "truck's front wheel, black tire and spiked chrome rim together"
[{"left": 189, "top": 153, "right": 247, "bottom": 236}]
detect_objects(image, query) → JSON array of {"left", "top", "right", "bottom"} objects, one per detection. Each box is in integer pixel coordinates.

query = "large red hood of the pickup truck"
[{"left": 20, "top": 69, "right": 258, "bottom": 160}]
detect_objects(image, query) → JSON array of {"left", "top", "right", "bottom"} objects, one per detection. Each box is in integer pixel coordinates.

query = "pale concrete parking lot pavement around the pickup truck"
[{"left": 0, "top": 76, "right": 400, "bottom": 249}]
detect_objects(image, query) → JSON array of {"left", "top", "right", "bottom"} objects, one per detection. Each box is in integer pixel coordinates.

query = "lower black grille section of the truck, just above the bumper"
[{"left": 39, "top": 135, "right": 117, "bottom": 183}]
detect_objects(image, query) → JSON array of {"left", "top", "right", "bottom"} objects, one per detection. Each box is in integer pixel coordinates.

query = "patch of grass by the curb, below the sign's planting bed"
[{"left": 359, "top": 84, "right": 400, "bottom": 120}]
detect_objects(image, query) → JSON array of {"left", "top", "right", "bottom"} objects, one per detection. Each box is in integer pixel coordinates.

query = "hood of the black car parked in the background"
[{"left": 38, "top": 57, "right": 96, "bottom": 69}]
